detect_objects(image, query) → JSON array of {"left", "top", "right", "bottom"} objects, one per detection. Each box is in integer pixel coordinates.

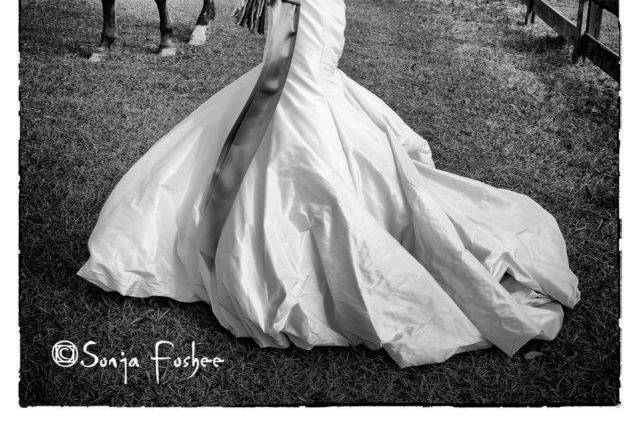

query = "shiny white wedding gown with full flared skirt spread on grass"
[{"left": 79, "top": 0, "right": 579, "bottom": 367}]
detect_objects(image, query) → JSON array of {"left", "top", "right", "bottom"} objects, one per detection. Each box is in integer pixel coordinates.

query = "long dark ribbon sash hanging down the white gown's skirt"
[{"left": 197, "top": 0, "right": 300, "bottom": 270}]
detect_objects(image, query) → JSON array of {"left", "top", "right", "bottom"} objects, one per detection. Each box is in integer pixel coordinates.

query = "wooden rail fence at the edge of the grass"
[{"left": 521, "top": 0, "right": 619, "bottom": 81}]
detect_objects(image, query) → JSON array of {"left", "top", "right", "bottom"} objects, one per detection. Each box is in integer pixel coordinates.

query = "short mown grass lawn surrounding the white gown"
[{"left": 19, "top": 0, "right": 619, "bottom": 406}]
